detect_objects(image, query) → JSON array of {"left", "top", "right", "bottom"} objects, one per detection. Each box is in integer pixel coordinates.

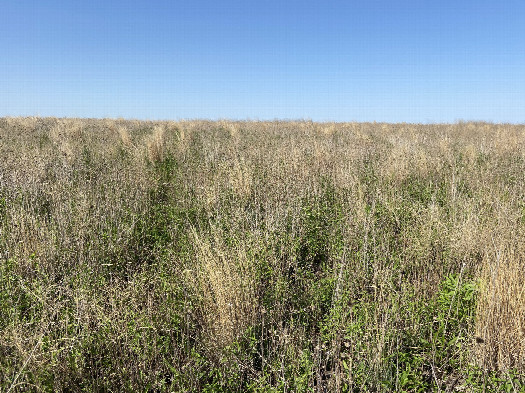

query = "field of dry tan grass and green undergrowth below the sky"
[{"left": 0, "top": 118, "right": 525, "bottom": 393}]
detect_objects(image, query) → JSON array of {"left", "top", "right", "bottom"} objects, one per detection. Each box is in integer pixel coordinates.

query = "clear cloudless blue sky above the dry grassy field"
[{"left": 0, "top": 0, "right": 525, "bottom": 123}]
